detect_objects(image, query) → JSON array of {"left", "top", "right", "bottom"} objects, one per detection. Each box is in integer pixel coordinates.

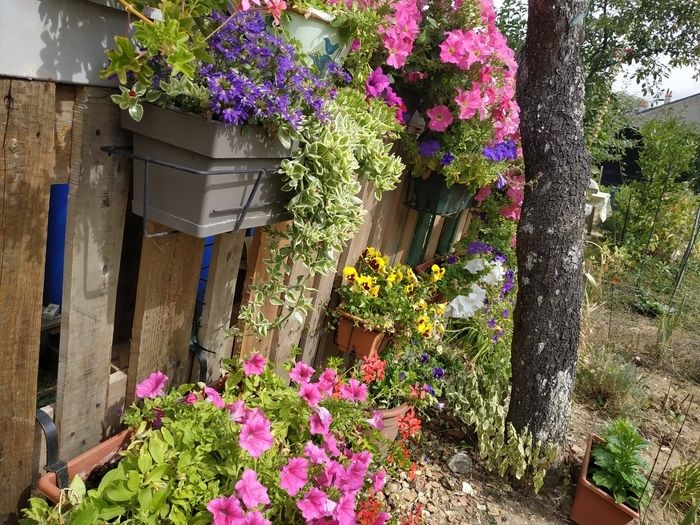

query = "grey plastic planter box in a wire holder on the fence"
[{"left": 122, "top": 105, "right": 292, "bottom": 237}]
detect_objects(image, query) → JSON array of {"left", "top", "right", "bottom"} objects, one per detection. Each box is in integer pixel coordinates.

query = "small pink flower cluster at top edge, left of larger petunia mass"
[{"left": 379, "top": 0, "right": 422, "bottom": 69}]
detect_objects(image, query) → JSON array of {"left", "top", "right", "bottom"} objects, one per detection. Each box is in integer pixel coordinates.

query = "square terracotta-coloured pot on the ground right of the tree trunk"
[{"left": 571, "top": 434, "right": 639, "bottom": 525}]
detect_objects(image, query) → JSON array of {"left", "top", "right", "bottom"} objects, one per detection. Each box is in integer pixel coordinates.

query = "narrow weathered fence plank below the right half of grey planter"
[{"left": 199, "top": 230, "right": 245, "bottom": 380}]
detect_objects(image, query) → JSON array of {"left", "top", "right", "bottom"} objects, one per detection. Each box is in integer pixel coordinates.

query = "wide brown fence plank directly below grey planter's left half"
[{"left": 126, "top": 223, "right": 204, "bottom": 405}]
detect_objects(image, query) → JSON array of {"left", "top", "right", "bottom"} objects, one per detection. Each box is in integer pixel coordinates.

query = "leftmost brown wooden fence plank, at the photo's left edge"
[{"left": 0, "top": 79, "right": 55, "bottom": 523}]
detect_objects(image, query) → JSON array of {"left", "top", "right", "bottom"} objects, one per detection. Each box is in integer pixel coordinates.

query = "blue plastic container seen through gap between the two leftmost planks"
[{"left": 44, "top": 184, "right": 68, "bottom": 305}]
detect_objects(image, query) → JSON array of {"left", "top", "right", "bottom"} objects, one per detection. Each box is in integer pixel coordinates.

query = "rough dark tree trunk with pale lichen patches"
[{"left": 508, "top": 0, "right": 590, "bottom": 443}]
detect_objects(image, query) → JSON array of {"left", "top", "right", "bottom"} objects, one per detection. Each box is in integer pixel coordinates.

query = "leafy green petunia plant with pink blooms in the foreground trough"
[{"left": 23, "top": 355, "right": 396, "bottom": 525}]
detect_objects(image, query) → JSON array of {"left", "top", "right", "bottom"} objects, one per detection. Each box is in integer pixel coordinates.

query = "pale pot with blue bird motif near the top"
[{"left": 283, "top": 9, "right": 350, "bottom": 74}]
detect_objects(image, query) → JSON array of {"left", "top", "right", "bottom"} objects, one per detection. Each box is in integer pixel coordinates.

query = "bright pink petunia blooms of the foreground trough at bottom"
[{"left": 205, "top": 357, "right": 390, "bottom": 525}]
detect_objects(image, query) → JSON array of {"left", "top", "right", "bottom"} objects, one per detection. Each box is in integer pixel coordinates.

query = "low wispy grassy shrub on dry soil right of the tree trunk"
[{"left": 575, "top": 348, "right": 647, "bottom": 419}]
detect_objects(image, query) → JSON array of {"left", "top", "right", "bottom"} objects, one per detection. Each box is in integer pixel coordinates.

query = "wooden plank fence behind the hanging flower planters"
[{"left": 0, "top": 78, "right": 466, "bottom": 522}]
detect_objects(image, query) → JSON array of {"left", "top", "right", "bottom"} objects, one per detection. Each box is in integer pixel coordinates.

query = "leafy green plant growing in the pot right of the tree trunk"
[{"left": 588, "top": 419, "right": 653, "bottom": 510}]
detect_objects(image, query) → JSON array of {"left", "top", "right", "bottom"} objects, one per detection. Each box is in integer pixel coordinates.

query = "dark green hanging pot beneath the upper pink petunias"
[{"left": 413, "top": 171, "right": 472, "bottom": 215}]
